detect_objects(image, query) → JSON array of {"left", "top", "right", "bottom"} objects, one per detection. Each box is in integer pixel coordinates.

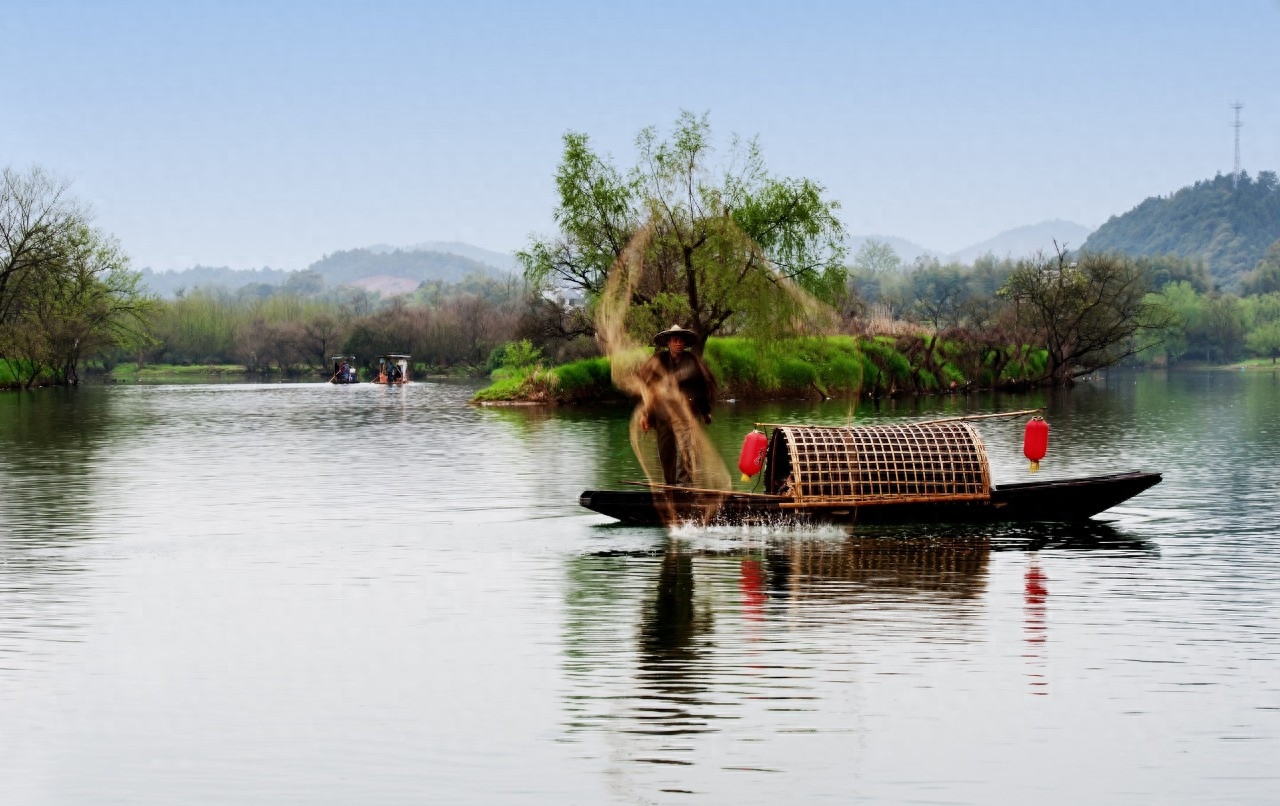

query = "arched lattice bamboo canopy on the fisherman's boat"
[{"left": 768, "top": 422, "right": 991, "bottom": 507}]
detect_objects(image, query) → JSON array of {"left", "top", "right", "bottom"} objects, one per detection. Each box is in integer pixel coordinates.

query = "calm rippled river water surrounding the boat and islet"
[{"left": 0, "top": 372, "right": 1280, "bottom": 803}]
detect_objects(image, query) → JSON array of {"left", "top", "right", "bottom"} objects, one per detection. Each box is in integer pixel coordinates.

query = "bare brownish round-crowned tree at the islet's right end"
[{"left": 1000, "top": 249, "right": 1176, "bottom": 386}]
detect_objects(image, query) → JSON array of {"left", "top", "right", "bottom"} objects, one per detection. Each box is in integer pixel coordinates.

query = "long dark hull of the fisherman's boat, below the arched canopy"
[{"left": 579, "top": 471, "right": 1161, "bottom": 525}]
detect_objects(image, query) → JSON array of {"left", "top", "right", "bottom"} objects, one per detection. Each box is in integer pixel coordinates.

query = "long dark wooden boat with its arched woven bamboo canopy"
[{"left": 579, "top": 421, "right": 1161, "bottom": 525}]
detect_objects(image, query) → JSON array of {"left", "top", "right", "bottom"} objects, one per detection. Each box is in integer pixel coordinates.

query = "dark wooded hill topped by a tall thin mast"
[{"left": 1084, "top": 171, "right": 1280, "bottom": 290}]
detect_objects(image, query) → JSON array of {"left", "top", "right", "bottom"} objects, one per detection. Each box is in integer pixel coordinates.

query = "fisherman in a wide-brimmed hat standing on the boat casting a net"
[{"left": 640, "top": 325, "right": 716, "bottom": 486}]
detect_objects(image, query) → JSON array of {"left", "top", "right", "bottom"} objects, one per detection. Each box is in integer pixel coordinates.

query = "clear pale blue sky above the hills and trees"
[{"left": 0, "top": 0, "right": 1280, "bottom": 269}]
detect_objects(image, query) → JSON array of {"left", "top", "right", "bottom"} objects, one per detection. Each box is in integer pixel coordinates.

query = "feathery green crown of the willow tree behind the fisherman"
[{"left": 517, "top": 113, "right": 846, "bottom": 345}]
